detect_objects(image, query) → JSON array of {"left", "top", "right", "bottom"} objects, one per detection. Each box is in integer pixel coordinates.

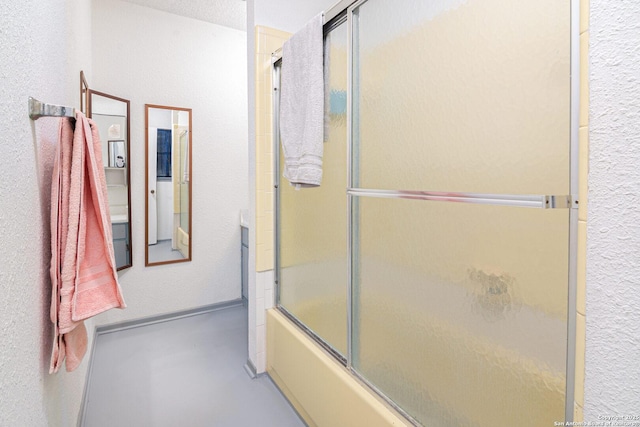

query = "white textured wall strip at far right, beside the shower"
[{"left": 584, "top": 0, "right": 640, "bottom": 421}]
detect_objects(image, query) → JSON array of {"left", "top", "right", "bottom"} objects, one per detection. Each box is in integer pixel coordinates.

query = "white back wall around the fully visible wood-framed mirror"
[{"left": 89, "top": 0, "right": 248, "bottom": 324}]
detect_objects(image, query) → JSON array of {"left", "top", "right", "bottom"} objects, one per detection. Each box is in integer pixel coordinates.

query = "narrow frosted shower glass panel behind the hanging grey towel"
[{"left": 280, "top": 24, "right": 348, "bottom": 357}]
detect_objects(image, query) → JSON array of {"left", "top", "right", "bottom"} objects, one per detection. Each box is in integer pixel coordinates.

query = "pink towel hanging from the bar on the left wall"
[{"left": 49, "top": 112, "right": 126, "bottom": 373}]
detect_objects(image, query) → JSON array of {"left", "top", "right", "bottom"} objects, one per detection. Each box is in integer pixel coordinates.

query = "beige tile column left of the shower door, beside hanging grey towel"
[{"left": 255, "top": 25, "right": 291, "bottom": 271}]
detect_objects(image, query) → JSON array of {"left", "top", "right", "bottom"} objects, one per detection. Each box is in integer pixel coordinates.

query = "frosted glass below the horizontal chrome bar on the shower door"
[{"left": 352, "top": 197, "right": 569, "bottom": 427}]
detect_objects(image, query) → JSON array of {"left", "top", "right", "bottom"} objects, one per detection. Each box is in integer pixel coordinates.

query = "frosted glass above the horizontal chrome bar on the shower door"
[{"left": 354, "top": 0, "right": 571, "bottom": 195}]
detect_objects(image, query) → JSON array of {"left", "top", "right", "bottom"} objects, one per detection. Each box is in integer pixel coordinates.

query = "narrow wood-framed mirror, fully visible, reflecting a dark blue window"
[{"left": 145, "top": 104, "right": 192, "bottom": 265}]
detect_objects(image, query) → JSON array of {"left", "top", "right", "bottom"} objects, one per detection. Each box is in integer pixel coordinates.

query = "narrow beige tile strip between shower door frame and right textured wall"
[{"left": 574, "top": 0, "right": 589, "bottom": 421}]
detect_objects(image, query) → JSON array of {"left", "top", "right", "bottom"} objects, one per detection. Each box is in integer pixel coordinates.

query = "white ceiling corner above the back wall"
[{"left": 124, "top": 0, "right": 247, "bottom": 31}]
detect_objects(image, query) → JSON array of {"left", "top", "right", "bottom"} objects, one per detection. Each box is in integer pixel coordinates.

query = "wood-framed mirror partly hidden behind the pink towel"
[{"left": 85, "top": 90, "right": 132, "bottom": 270}]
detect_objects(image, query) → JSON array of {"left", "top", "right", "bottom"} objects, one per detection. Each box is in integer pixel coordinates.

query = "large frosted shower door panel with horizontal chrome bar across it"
[{"left": 349, "top": 0, "right": 571, "bottom": 426}]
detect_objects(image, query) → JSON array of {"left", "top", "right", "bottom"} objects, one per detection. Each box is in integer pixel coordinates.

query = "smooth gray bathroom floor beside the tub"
[{"left": 83, "top": 305, "right": 305, "bottom": 427}]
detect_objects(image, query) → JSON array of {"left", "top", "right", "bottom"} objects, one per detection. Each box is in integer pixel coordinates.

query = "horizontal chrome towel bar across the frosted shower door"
[{"left": 347, "top": 188, "right": 577, "bottom": 209}]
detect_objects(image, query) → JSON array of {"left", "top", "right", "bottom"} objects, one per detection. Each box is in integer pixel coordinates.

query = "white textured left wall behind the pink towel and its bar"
[{"left": 0, "top": 0, "right": 92, "bottom": 427}]
